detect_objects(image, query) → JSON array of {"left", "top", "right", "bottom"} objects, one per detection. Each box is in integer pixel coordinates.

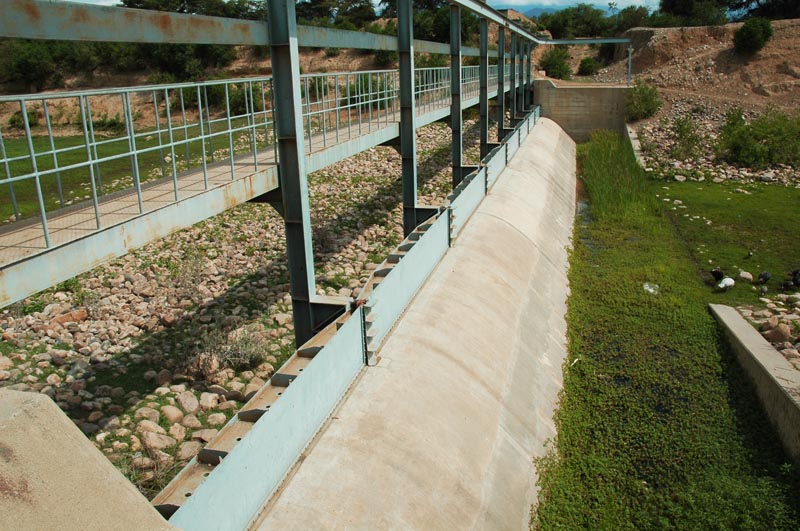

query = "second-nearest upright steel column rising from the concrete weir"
[{"left": 397, "top": 0, "right": 417, "bottom": 235}]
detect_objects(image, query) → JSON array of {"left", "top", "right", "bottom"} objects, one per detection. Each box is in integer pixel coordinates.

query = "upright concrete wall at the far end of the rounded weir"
[{"left": 533, "top": 79, "right": 628, "bottom": 142}]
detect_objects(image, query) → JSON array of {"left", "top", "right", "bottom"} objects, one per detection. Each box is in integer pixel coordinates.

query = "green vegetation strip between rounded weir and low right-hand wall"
[{"left": 532, "top": 133, "right": 800, "bottom": 531}]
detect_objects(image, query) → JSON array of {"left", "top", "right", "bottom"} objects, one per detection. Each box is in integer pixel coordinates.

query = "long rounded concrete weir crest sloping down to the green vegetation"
[{"left": 254, "top": 119, "right": 575, "bottom": 530}]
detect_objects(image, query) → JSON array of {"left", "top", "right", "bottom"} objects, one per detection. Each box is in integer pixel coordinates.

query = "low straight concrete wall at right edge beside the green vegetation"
[{"left": 709, "top": 304, "right": 800, "bottom": 462}]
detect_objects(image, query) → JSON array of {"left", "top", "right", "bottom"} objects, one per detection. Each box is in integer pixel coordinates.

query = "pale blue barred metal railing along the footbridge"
[{"left": 0, "top": 65, "right": 510, "bottom": 248}]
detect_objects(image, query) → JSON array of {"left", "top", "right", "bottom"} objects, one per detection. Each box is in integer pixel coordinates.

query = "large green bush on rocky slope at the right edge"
[{"left": 717, "top": 109, "right": 800, "bottom": 168}]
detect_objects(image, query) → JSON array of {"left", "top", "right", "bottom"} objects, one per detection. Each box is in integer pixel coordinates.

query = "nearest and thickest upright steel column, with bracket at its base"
[{"left": 267, "top": 0, "right": 344, "bottom": 347}]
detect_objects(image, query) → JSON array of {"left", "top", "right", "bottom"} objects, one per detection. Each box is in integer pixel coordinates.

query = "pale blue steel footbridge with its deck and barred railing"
[{"left": 0, "top": 66, "right": 511, "bottom": 303}]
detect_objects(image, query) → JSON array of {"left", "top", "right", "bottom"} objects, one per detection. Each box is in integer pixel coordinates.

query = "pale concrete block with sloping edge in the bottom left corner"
[{"left": 0, "top": 390, "right": 175, "bottom": 531}]
